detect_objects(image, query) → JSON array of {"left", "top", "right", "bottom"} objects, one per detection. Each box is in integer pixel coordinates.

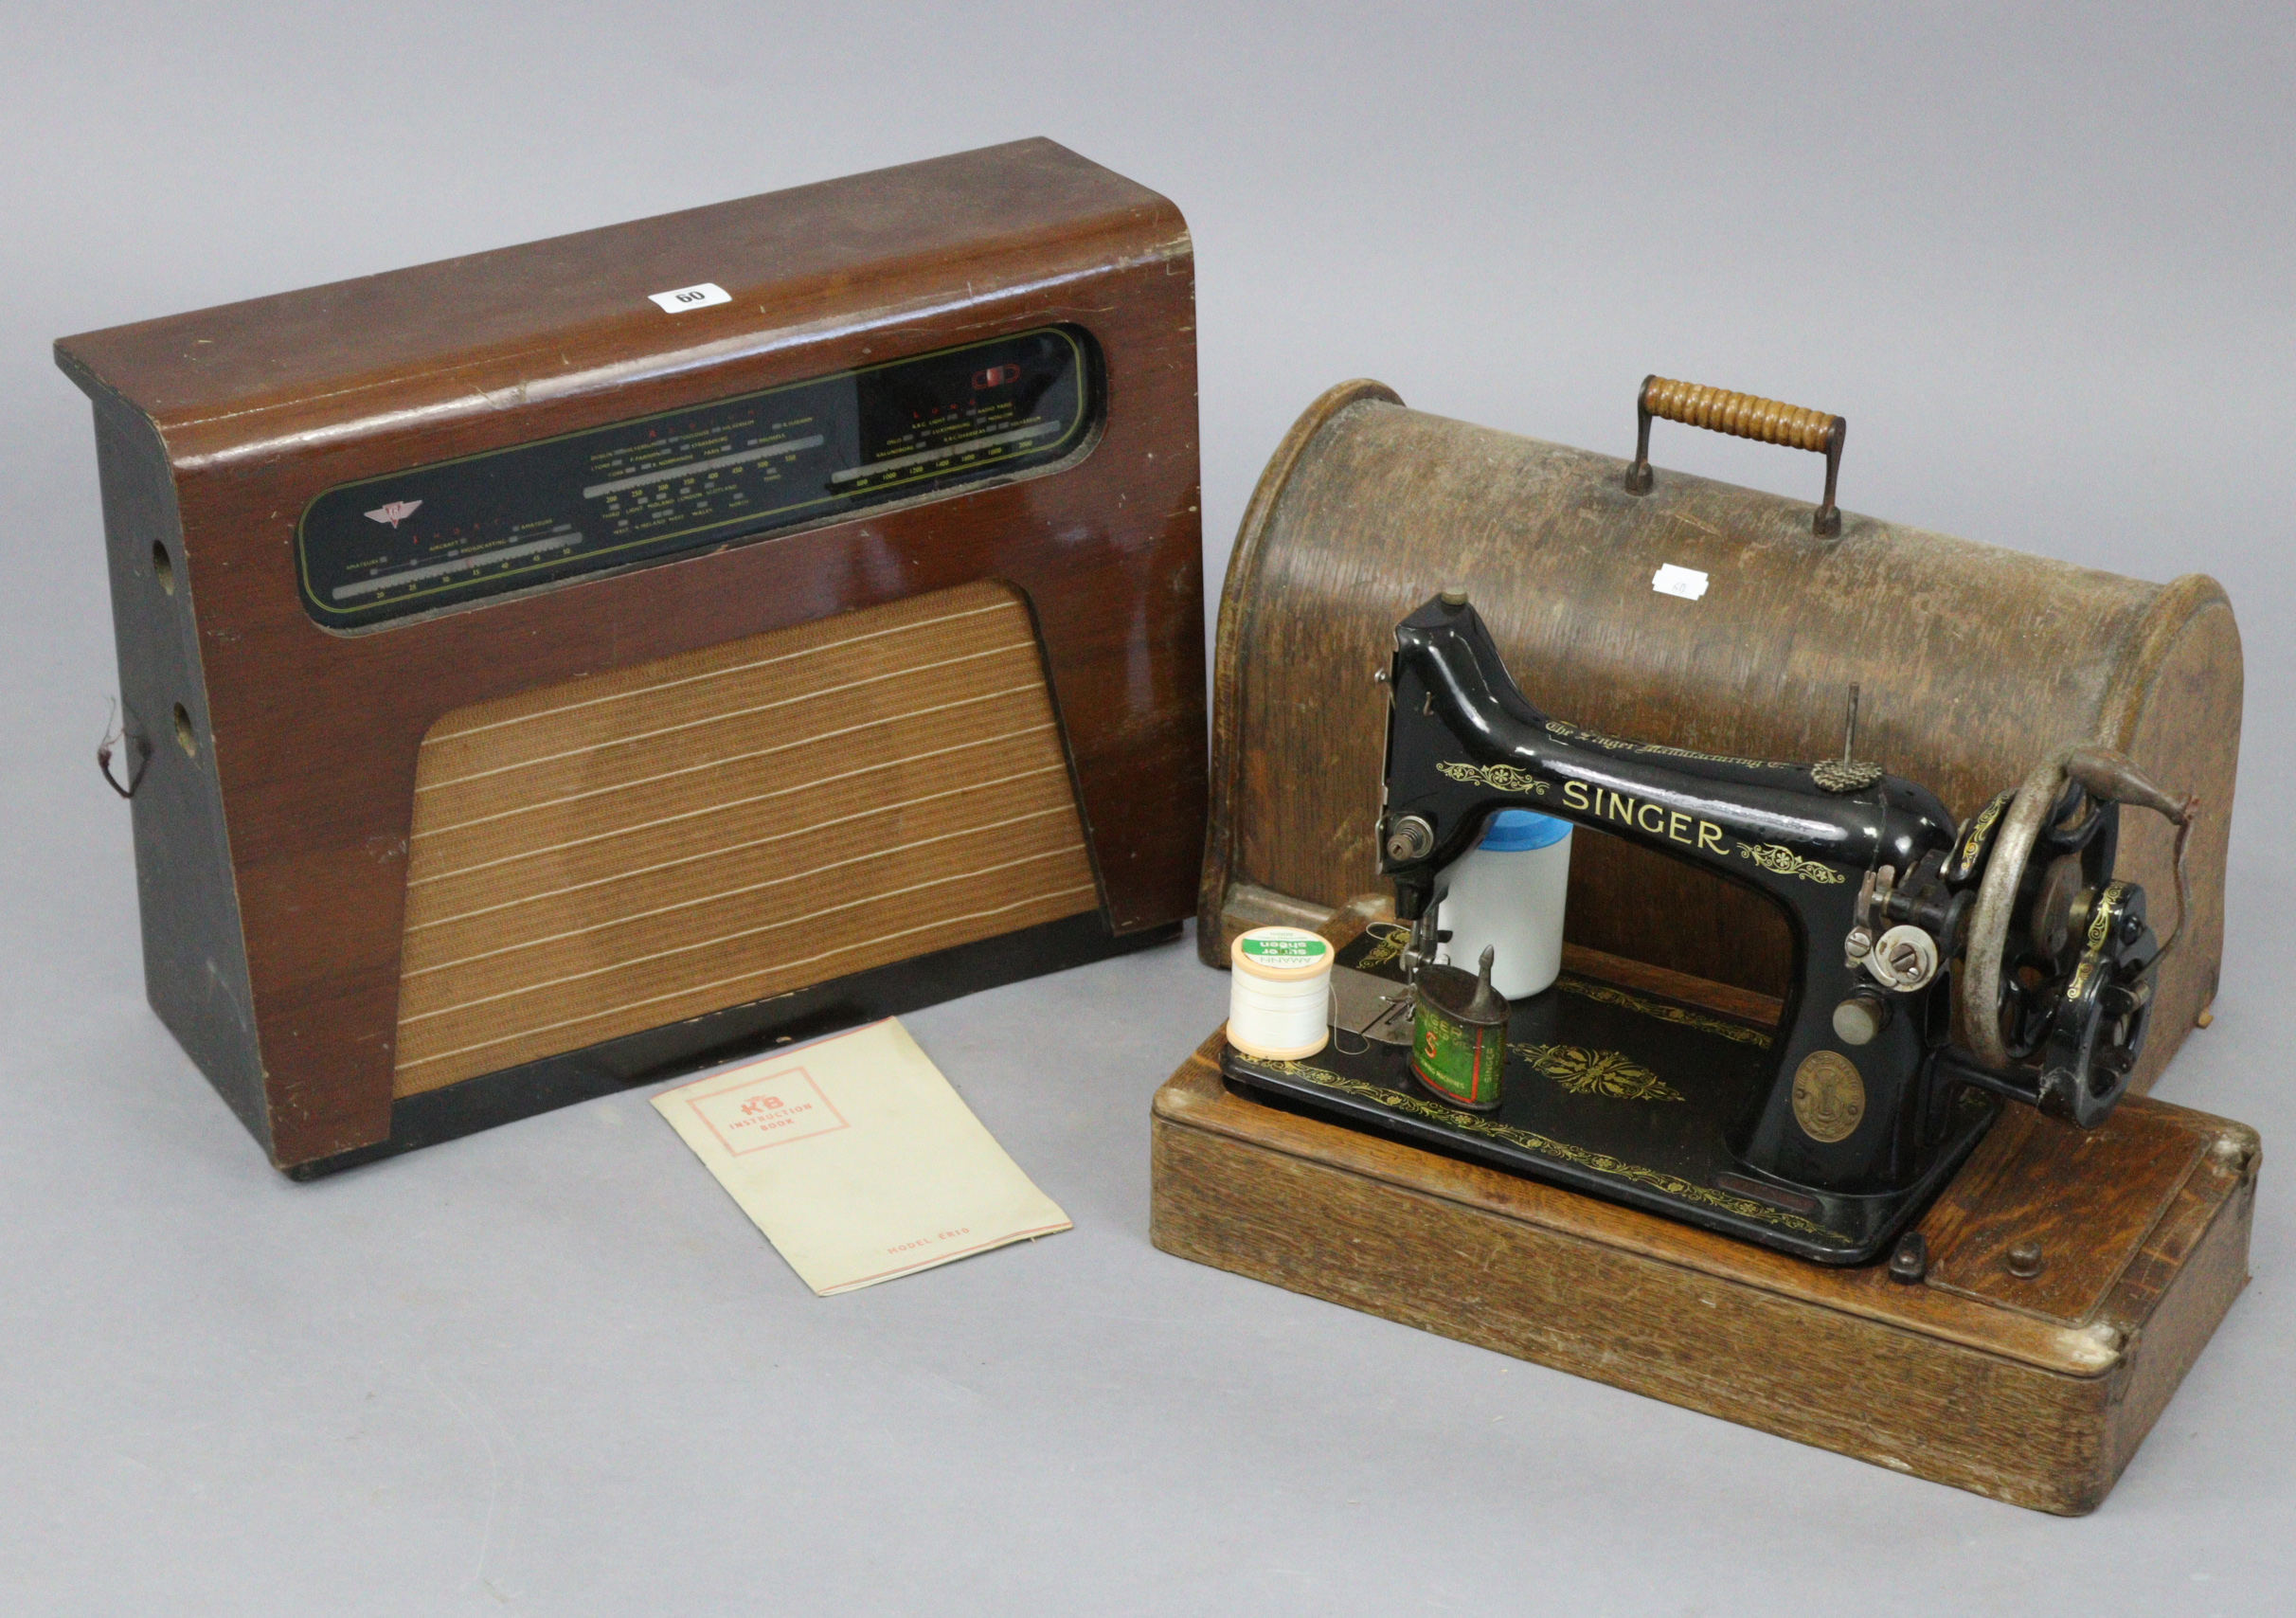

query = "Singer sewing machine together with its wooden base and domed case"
[{"left": 1150, "top": 376, "right": 2264, "bottom": 1513}]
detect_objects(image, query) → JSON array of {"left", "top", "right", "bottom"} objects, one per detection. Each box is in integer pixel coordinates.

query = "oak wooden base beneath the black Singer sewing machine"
[{"left": 1150, "top": 996, "right": 2262, "bottom": 1515}]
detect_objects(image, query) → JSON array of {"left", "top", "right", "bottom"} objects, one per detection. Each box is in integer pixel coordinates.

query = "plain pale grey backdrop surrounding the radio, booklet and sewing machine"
[{"left": 0, "top": 0, "right": 2296, "bottom": 1613}]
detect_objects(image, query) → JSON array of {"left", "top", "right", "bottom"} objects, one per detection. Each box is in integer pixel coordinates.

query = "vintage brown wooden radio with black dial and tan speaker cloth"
[{"left": 58, "top": 140, "right": 1206, "bottom": 1175}]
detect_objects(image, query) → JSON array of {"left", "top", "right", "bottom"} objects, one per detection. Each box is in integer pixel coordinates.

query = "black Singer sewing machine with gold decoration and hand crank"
[{"left": 1219, "top": 590, "right": 2199, "bottom": 1278}]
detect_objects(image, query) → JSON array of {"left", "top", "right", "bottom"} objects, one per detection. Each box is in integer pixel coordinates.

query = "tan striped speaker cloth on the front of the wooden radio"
[{"left": 395, "top": 583, "right": 1098, "bottom": 1095}]
